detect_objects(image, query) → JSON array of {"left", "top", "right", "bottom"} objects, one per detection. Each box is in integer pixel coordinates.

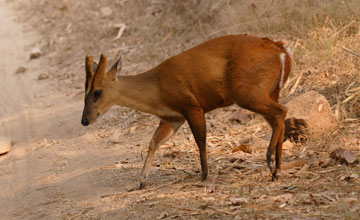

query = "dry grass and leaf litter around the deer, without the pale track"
[{"left": 7, "top": 0, "right": 360, "bottom": 219}]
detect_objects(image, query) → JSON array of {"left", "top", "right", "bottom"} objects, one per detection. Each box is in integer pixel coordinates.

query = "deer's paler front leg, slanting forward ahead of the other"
[{"left": 139, "top": 120, "right": 185, "bottom": 189}]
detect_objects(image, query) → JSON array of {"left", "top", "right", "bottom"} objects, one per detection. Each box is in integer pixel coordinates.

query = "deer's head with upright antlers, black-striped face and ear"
[{"left": 81, "top": 54, "right": 121, "bottom": 126}]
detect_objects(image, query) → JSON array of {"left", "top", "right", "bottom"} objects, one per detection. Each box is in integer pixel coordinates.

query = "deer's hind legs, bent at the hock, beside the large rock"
[{"left": 236, "top": 96, "right": 287, "bottom": 180}]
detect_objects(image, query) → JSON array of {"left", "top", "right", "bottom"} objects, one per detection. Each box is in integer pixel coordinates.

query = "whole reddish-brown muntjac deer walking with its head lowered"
[{"left": 81, "top": 35, "right": 292, "bottom": 189}]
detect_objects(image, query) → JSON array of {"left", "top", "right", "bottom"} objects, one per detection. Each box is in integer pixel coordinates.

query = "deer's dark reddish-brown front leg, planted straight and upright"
[{"left": 185, "top": 109, "right": 209, "bottom": 180}]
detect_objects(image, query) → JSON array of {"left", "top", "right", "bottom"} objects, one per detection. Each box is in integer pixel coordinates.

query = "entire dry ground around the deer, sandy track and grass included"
[{"left": 0, "top": 0, "right": 360, "bottom": 219}]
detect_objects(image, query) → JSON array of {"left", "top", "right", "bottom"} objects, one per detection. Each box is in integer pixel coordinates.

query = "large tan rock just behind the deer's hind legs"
[{"left": 286, "top": 91, "right": 337, "bottom": 136}]
